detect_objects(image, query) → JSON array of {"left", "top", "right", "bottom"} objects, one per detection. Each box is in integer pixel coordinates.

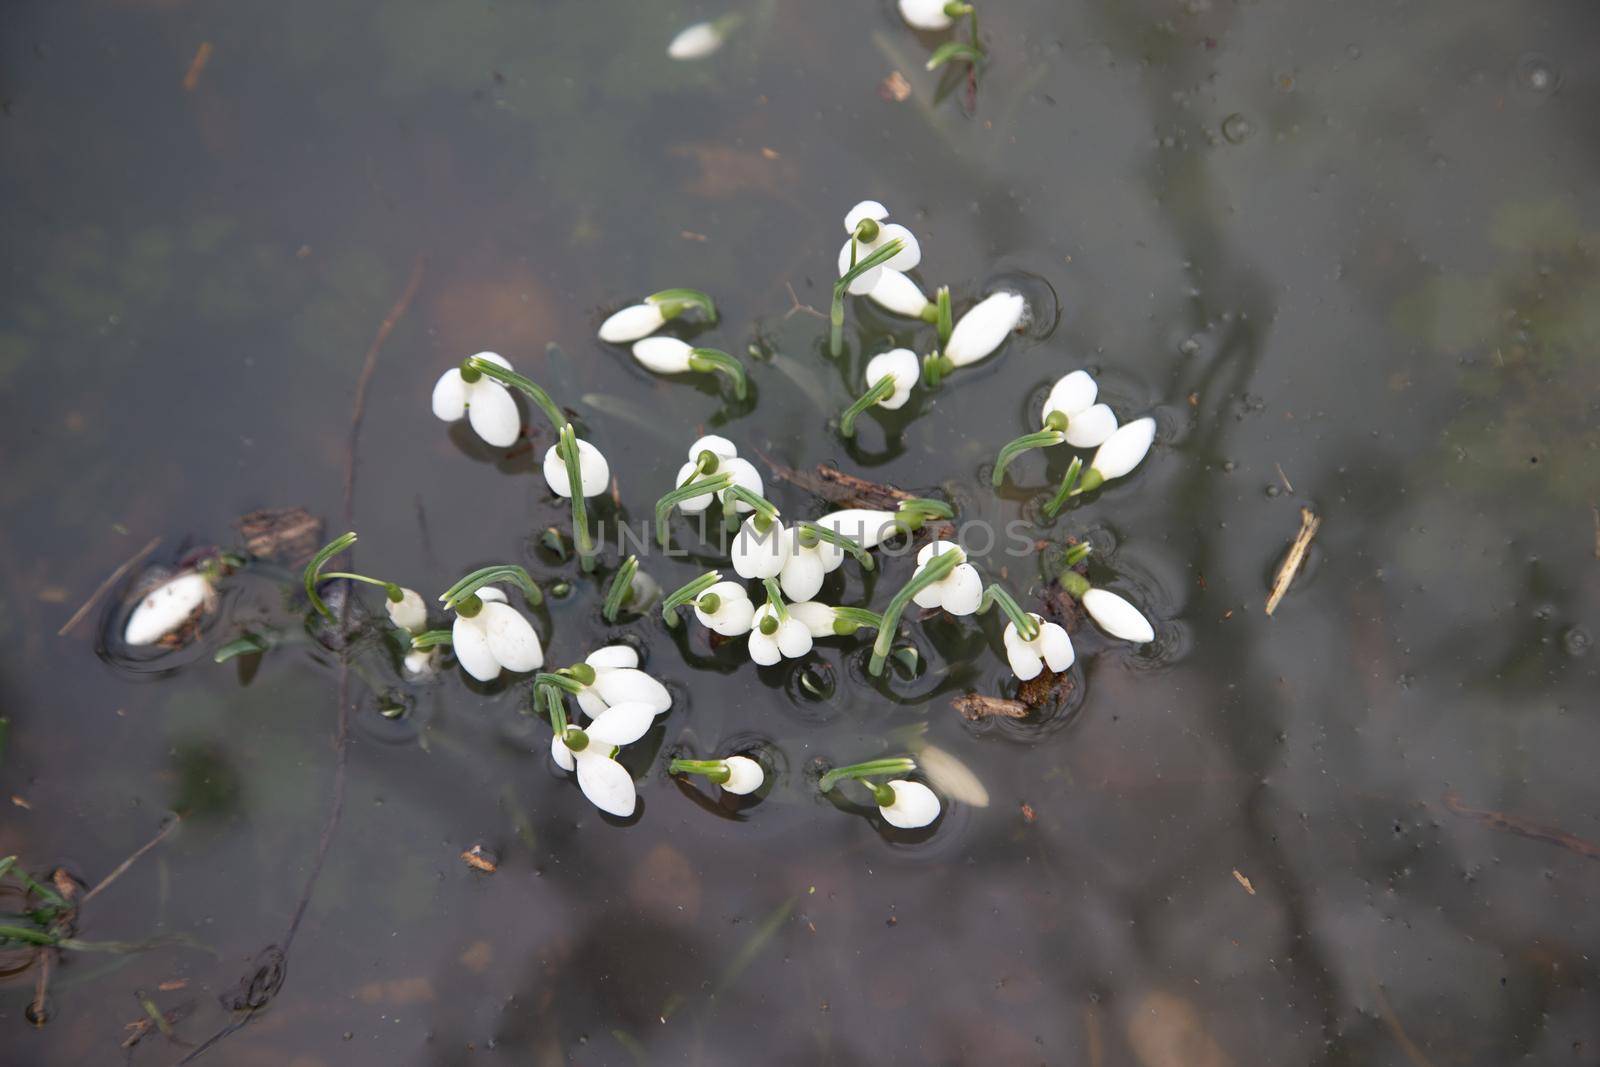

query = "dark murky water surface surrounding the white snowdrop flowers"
[{"left": 0, "top": 0, "right": 1600, "bottom": 1067}]
